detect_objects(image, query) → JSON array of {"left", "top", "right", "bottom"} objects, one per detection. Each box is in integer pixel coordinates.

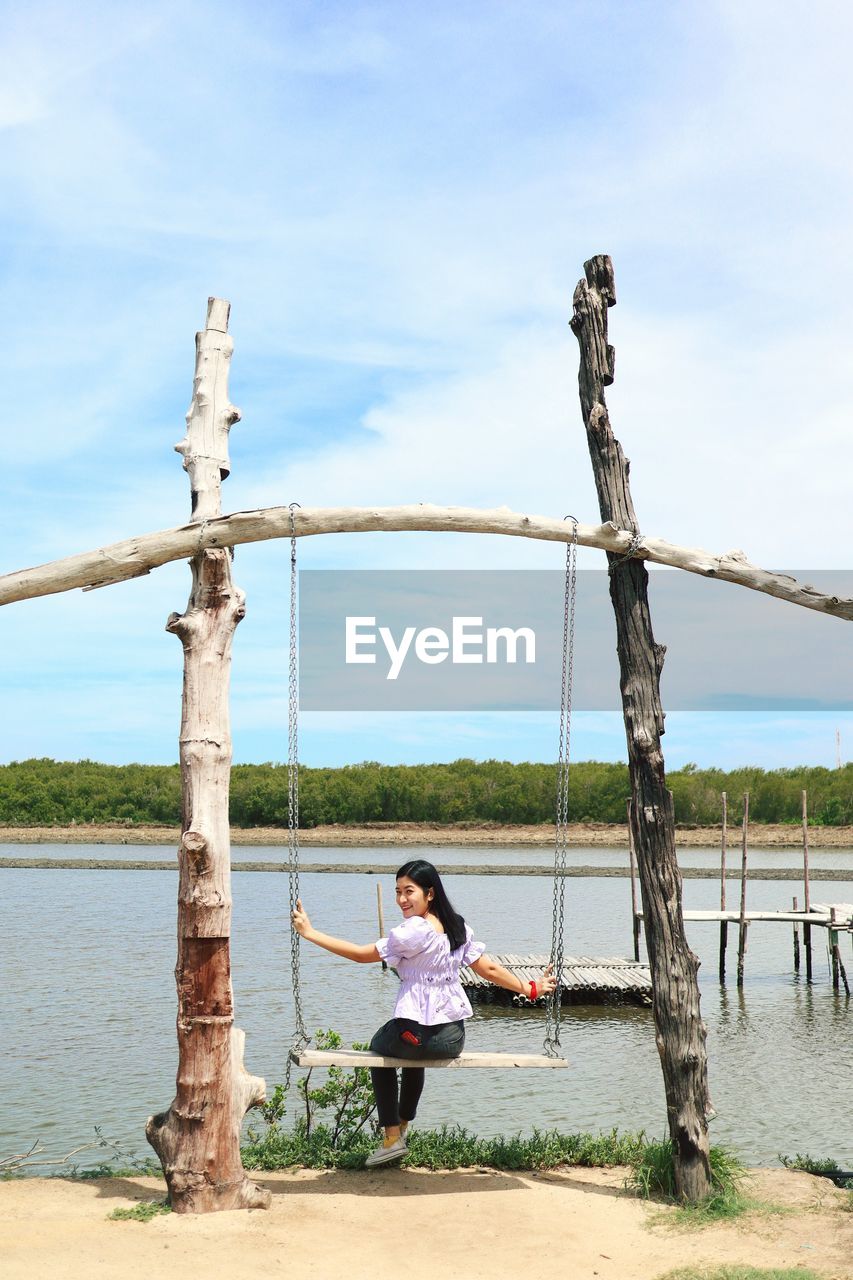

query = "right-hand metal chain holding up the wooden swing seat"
[{"left": 543, "top": 516, "right": 578, "bottom": 1057}]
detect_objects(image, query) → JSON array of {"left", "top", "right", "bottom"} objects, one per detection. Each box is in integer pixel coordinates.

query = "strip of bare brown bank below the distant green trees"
[{"left": 0, "top": 822, "right": 853, "bottom": 849}]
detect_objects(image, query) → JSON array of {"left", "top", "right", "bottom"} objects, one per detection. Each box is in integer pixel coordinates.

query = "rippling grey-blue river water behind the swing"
[{"left": 0, "top": 845, "right": 853, "bottom": 1171}]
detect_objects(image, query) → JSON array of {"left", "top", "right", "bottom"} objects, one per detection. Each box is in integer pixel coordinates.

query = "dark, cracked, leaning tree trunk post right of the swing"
[{"left": 571, "top": 255, "right": 713, "bottom": 1203}]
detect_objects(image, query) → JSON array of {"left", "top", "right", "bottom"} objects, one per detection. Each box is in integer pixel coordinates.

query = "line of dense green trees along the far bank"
[{"left": 0, "top": 759, "right": 853, "bottom": 827}]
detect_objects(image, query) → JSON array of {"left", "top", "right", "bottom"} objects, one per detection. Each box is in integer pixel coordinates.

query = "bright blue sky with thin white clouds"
[{"left": 0, "top": 0, "right": 853, "bottom": 768}]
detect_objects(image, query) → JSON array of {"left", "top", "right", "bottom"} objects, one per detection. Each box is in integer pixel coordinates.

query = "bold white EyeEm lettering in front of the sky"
[{"left": 346, "top": 614, "right": 537, "bottom": 680}]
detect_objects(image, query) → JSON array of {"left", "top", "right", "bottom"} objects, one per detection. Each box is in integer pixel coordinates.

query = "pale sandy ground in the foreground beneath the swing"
[{"left": 0, "top": 1169, "right": 853, "bottom": 1280}]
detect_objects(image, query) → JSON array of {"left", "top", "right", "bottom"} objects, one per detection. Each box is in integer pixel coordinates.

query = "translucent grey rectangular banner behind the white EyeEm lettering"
[{"left": 300, "top": 570, "right": 853, "bottom": 712}]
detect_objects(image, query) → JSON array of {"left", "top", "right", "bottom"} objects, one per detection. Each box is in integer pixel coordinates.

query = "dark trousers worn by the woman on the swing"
[{"left": 370, "top": 1018, "right": 465, "bottom": 1129}]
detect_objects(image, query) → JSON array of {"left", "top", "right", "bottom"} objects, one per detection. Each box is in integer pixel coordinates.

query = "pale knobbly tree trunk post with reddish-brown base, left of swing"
[{"left": 146, "top": 298, "right": 270, "bottom": 1213}]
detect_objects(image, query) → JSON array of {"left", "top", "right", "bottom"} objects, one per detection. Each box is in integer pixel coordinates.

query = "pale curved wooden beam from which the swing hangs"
[{"left": 0, "top": 503, "right": 853, "bottom": 622}]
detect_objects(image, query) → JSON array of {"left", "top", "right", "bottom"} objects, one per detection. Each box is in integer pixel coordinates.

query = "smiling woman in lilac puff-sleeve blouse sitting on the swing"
[{"left": 292, "top": 858, "right": 556, "bottom": 1166}]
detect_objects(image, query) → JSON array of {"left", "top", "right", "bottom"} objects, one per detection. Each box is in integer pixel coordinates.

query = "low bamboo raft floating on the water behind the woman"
[{"left": 460, "top": 951, "right": 652, "bottom": 1006}]
